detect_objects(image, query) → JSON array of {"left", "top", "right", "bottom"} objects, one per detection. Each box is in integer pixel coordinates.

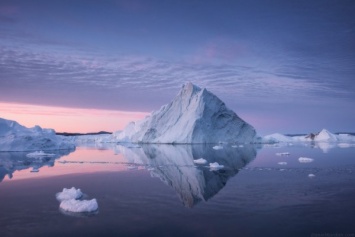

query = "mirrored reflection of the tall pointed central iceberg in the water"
[{"left": 117, "top": 145, "right": 256, "bottom": 207}]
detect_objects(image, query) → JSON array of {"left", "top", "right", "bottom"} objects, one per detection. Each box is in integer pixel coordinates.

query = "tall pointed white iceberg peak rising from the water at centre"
[{"left": 113, "top": 83, "right": 256, "bottom": 144}]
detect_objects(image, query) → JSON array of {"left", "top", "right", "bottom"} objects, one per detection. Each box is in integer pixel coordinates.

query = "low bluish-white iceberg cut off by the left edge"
[{"left": 0, "top": 118, "right": 75, "bottom": 151}]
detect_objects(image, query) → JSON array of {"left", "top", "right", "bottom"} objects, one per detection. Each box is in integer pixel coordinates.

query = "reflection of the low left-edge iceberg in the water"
[{"left": 0, "top": 149, "right": 74, "bottom": 182}]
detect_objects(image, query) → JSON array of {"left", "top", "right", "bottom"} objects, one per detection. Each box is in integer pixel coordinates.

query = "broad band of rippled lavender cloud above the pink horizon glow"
[{"left": 0, "top": 47, "right": 351, "bottom": 111}]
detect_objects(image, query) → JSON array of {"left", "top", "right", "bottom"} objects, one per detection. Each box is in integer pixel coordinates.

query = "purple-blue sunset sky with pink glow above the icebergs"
[{"left": 0, "top": 0, "right": 355, "bottom": 135}]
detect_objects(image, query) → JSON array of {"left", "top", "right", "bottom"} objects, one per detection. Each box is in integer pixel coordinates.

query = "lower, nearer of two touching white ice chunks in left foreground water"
[{"left": 59, "top": 198, "right": 99, "bottom": 212}]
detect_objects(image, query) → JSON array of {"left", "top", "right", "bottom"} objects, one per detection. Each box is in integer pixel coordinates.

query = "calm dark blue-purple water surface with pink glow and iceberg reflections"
[{"left": 0, "top": 144, "right": 355, "bottom": 237}]
